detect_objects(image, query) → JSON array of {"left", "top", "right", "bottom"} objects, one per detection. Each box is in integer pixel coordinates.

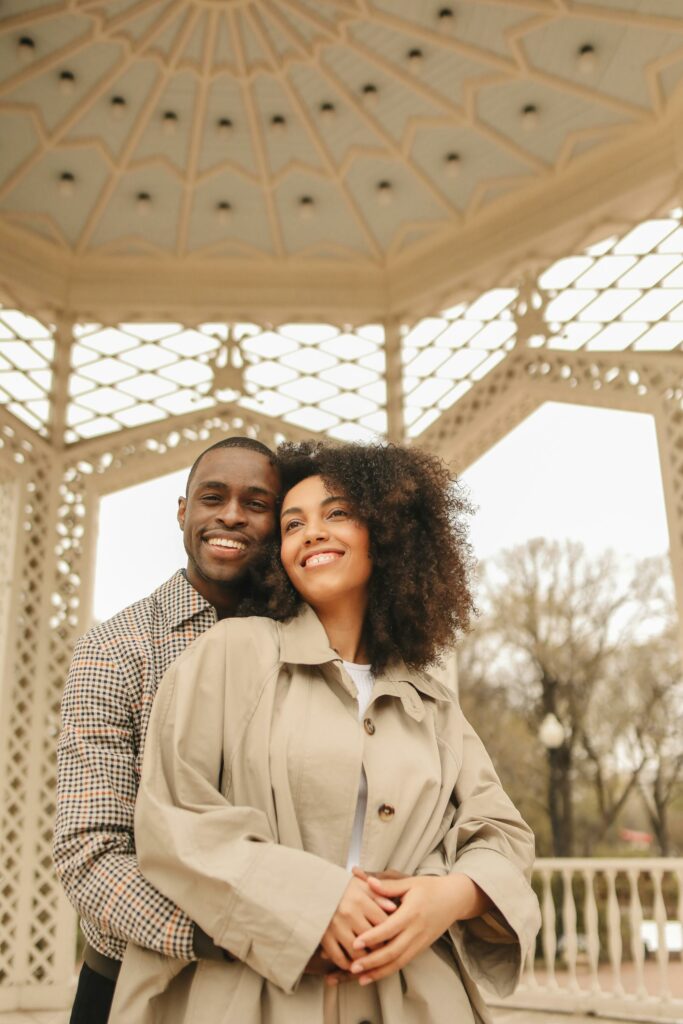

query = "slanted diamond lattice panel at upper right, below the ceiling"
[{"left": 402, "top": 209, "right": 683, "bottom": 437}]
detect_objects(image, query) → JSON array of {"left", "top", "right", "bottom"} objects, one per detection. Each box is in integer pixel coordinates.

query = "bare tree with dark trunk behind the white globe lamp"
[{"left": 460, "top": 540, "right": 671, "bottom": 856}]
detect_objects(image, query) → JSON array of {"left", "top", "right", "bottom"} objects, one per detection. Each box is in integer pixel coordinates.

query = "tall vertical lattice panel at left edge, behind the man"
[{"left": 0, "top": 409, "right": 73, "bottom": 999}]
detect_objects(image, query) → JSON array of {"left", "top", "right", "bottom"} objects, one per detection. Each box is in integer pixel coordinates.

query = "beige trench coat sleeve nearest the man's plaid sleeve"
[{"left": 135, "top": 624, "right": 349, "bottom": 991}]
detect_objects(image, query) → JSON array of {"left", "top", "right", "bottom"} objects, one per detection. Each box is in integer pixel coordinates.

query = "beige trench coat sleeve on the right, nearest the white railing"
[{"left": 432, "top": 712, "right": 541, "bottom": 996}]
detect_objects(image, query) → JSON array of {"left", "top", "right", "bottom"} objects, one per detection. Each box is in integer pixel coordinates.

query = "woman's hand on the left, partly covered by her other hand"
[{"left": 321, "top": 876, "right": 396, "bottom": 971}]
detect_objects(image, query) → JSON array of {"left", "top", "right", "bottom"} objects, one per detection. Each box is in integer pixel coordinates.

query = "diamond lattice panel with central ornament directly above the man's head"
[{"left": 66, "top": 324, "right": 386, "bottom": 442}]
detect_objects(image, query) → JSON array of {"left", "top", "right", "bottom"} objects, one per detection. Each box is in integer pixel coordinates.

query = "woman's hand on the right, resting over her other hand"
[{"left": 348, "top": 874, "right": 490, "bottom": 985}]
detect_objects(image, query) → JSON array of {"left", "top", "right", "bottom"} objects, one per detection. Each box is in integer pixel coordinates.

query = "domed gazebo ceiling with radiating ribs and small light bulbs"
[{"left": 0, "top": 0, "right": 683, "bottom": 315}]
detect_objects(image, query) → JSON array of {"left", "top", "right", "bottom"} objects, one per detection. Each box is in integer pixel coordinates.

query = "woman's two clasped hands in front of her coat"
[{"left": 315, "top": 868, "right": 489, "bottom": 985}]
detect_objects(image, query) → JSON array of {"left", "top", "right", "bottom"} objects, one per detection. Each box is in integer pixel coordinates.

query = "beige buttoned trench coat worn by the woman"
[{"left": 110, "top": 608, "right": 539, "bottom": 1024}]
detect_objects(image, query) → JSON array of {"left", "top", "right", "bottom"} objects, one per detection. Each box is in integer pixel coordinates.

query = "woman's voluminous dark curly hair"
[{"left": 268, "top": 441, "right": 474, "bottom": 672}]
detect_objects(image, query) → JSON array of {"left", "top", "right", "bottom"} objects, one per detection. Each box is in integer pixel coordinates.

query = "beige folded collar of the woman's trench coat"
[{"left": 276, "top": 604, "right": 455, "bottom": 718}]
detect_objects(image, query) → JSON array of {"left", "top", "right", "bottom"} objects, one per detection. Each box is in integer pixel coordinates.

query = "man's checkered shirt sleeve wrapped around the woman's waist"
[{"left": 53, "top": 636, "right": 196, "bottom": 959}]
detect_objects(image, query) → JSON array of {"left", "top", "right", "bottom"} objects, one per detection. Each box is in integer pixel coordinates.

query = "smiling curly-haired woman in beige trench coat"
[{"left": 112, "top": 443, "right": 539, "bottom": 1024}]
